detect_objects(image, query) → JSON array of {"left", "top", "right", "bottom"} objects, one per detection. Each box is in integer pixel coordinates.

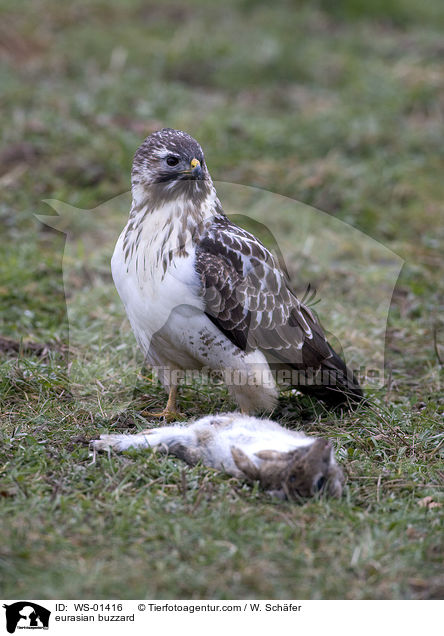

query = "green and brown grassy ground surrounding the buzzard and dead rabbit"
[{"left": 0, "top": 0, "right": 444, "bottom": 599}]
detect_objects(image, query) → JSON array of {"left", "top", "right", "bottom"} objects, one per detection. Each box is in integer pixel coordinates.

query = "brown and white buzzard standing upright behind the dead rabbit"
[{"left": 111, "top": 128, "right": 362, "bottom": 420}]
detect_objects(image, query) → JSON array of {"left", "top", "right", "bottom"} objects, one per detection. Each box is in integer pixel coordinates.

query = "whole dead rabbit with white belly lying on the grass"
[{"left": 91, "top": 413, "right": 344, "bottom": 499}]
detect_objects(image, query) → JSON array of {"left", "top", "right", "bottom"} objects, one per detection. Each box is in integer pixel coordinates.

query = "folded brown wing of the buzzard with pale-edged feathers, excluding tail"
[{"left": 196, "top": 216, "right": 331, "bottom": 368}]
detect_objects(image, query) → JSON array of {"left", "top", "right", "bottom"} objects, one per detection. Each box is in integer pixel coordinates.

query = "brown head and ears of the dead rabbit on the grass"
[{"left": 232, "top": 438, "right": 344, "bottom": 500}]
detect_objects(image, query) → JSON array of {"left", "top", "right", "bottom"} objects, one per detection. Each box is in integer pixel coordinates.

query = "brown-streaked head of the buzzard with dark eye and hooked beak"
[{"left": 131, "top": 128, "right": 211, "bottom": 200}]
